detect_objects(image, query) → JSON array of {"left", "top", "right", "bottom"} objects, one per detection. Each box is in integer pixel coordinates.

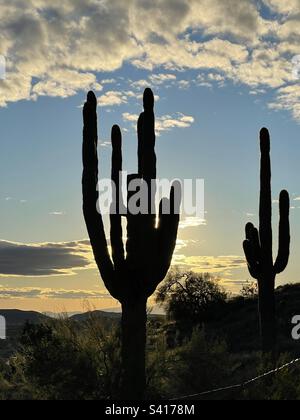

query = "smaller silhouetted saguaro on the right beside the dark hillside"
[{"left": 244, "top": 128, "right": 290, "bottom": 352}]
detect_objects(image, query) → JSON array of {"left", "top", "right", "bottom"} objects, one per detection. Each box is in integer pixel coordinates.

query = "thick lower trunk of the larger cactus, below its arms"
[{"left": 122, "top": 299, "right": 147, "bottom": 400}]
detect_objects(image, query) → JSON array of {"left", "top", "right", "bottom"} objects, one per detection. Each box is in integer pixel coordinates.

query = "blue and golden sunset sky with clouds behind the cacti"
[{"left": 0, "top": 0, "right": 300, "bottom": 312}]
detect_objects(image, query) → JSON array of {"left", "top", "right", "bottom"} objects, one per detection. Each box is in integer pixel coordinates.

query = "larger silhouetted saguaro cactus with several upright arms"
[{"left": 82, "top": 89, "right": 179, "bottom": 399}]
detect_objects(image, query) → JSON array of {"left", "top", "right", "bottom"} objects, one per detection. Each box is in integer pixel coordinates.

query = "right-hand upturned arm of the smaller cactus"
[{"left": 274, "top": 191, "right": 291, "bottom": 274}]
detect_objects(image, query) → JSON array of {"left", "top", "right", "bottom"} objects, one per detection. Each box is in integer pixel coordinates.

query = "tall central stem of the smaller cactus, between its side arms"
[{"left": 259, "top": 128, "right": 273, "bottom": 269}]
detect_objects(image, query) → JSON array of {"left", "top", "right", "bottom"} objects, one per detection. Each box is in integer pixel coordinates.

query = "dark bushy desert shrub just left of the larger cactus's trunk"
[{"left": 17, "top": 318, "right": 120, "bottom": 400}]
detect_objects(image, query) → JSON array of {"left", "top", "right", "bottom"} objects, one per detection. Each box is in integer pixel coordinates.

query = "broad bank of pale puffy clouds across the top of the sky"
[{"left": 0, "top": 0, "right": 300, "bottom": 119}]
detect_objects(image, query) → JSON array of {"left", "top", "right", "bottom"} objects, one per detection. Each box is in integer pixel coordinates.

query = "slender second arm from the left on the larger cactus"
[{"left": 110, "top": 125, "right": 125, "bottom": 268}]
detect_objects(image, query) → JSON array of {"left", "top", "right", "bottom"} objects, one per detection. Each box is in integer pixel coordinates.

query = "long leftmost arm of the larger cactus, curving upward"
[{"left": 82, "top": 92, "right": 115, "bottom": 296}]
